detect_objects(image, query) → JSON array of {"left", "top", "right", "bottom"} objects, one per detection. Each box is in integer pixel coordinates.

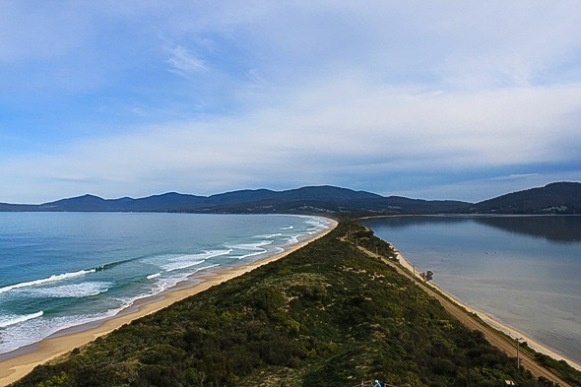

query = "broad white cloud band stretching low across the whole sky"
[{"left": 2, "top": 76, "right": 581, "bottom": 203}]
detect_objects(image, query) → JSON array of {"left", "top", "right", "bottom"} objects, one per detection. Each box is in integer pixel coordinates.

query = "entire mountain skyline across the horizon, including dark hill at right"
[{"left": 0, "top": 182, "right": 581, "bottom": 215}]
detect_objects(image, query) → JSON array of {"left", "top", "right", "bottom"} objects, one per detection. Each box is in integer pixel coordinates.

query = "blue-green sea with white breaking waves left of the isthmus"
[{"left": 0, "top": 212, "right": 329, "bottom": 358}]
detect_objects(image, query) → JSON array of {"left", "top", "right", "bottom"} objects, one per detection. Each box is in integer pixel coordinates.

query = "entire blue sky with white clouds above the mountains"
[{"left": 0, "top": 0, "right": 581, "bottom": 203}]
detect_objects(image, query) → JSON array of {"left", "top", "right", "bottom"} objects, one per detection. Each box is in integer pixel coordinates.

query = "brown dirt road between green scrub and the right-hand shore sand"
[{"left": 357, "top": 242, "right": 569, "bottom": 386}]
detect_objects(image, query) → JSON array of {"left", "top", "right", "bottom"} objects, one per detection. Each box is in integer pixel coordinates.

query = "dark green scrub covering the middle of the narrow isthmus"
[{"left": 15, "top": 222, "right": 572, "bottom": 387}]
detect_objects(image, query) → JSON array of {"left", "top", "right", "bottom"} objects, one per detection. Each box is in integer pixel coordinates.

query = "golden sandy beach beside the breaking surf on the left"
[{"left": 0, "top": 219, "right": 337, "bottom": 386}]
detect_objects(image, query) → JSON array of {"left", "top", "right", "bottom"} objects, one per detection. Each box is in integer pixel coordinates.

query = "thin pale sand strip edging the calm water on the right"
[{"left": 391, "top": 249, "right": 581, "bottom": 371}]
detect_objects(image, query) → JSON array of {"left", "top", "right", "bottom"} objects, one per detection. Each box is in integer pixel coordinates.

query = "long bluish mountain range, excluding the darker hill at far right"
[{"left": 0, "top": 186, "right": 471, "bottom": 214}]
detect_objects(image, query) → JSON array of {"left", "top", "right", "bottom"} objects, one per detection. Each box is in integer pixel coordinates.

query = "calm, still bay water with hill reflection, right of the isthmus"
[{"left": 364, "top": 216, "right": 581, "bottom": 364}]
